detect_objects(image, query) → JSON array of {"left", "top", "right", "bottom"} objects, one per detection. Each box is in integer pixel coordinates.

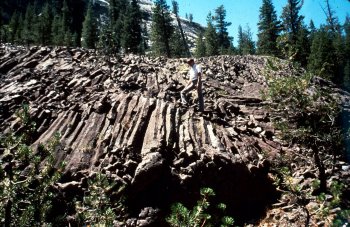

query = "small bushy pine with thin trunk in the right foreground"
[{"left": 264, "top": 59, "right": 344, "bottom": 191}]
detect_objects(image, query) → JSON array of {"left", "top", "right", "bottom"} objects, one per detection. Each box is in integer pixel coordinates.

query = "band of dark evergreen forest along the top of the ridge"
[{"left": 0, "top": 0, "right": 350, "bottom": 88}]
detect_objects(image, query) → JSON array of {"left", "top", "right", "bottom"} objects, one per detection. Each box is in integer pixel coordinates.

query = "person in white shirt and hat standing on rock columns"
[{"left": 181, "top": 58, "right": 204, "bottom": 112}]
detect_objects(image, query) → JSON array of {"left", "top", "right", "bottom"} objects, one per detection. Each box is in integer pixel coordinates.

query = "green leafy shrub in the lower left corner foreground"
[{"left": 0, "top": 105, "right": 64, "bottom": 226}]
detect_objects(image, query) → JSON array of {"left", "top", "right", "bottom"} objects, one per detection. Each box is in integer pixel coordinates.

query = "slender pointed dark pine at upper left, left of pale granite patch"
[{"left": 82, "top": 0, "right": 97, "bottom": 49}]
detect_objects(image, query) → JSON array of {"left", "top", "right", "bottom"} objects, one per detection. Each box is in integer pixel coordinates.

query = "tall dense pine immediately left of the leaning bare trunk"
[{"left": 151, "top": 0, "right": 174, "bottom": 57}]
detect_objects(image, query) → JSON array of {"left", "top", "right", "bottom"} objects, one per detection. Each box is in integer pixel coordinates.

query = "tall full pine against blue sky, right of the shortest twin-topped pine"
[{"left": 257, "top": 0, "right": 280, "bottom": 56}]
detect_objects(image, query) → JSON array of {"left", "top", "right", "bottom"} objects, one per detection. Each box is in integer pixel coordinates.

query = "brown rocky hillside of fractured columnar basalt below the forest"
[{"left": 0, "top": 45, "right": 350, "bottom": 226}]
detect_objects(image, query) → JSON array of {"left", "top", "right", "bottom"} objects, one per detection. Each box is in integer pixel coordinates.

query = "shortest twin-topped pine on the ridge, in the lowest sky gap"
[{"left": 238, "top": 25, "right": 255, "bottom": 55}]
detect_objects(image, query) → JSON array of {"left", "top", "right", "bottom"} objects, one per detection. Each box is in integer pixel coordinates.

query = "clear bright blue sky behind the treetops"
[{"left": 167, "top": 0, "right": 350, "bottom": 45}]
